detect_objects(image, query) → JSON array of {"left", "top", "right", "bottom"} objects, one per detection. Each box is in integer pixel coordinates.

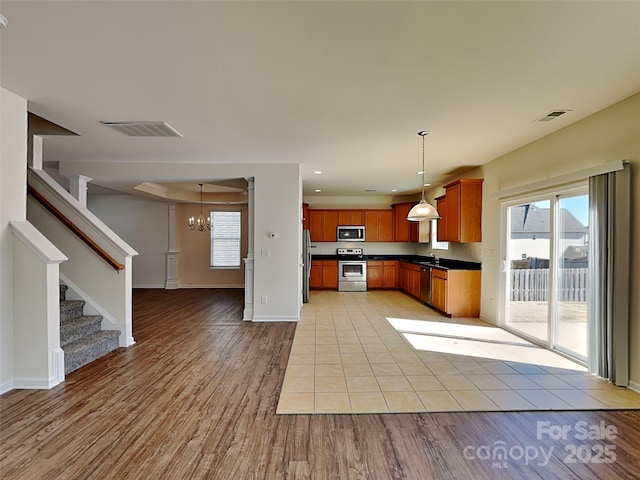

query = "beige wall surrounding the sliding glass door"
[{"left": 481, "top": 94, "right": 640, "bottom": 389}]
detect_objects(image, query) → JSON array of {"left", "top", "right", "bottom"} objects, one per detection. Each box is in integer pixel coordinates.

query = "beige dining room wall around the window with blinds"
[{"left": 176, "top": 204, "right": 248, "bottom": 288}]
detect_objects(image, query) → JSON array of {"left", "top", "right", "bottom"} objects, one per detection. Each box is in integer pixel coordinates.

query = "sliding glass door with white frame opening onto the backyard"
[{"left": 502, "top": 185, "right": 589, "bottom": 362}]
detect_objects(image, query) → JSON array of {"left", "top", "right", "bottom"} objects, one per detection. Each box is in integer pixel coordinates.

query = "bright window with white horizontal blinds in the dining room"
[{"left": 210, "top": 212, "right": 240, "bottom": 268}]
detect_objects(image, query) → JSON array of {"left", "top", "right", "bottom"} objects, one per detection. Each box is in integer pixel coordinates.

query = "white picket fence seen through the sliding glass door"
[{"left": 511, "top": 268, "right": 588, "bottom": 302}]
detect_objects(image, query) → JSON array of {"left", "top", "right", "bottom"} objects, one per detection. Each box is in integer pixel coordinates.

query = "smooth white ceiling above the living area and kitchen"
[{"left": 0, "top": 0, "right": 640, "bottom": 196}]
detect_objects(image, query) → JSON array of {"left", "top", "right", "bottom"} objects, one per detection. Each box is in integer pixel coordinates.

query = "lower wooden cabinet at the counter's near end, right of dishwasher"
[{"left": 431, "top": 268, "right": 481, "bottom": 318}]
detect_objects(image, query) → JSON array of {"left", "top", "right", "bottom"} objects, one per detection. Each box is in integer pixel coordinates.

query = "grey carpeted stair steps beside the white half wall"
[{"left": 60, "top": 285, "right": 120, "bottom": 375}]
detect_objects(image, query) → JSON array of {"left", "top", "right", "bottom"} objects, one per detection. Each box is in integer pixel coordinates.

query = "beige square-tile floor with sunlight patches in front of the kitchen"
[{"left": 277, "top": 291, "right": 640, "bottom": 414}]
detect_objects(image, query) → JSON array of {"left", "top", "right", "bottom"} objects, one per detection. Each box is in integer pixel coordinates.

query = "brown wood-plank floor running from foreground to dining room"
[{"left": 0, "top": 289, "right": 640, "bottom": 480}]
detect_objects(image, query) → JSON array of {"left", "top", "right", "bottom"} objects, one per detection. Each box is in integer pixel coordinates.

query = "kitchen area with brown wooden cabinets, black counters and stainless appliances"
[{"left": 303, "top": 179, "right": 482, "bottom": 317}]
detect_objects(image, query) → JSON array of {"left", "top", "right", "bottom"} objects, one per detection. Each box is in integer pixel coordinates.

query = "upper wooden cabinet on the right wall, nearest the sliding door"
[{"left": 436, "top": 178, "right": 483, "bottom": 242}]
